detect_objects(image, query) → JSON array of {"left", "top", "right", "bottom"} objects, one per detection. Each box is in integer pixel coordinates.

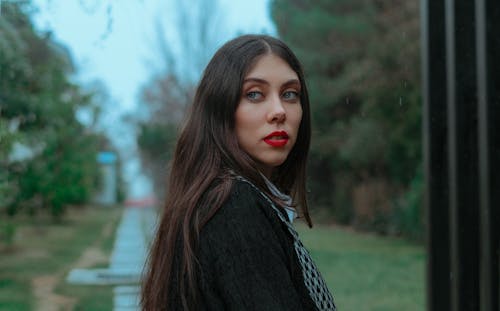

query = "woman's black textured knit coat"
[{"left": 169, "top": 180, "right": 317, "bottom": 311}]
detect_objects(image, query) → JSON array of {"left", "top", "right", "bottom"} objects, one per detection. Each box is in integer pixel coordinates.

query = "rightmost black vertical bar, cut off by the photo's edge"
[{"left": 476, "top": 0, "right": 500, "bottom": 311}]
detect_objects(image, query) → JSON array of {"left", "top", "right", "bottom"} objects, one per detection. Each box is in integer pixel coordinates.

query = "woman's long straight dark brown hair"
[{"left": 141, "top": 35, "right": 312, "bottom": 311}]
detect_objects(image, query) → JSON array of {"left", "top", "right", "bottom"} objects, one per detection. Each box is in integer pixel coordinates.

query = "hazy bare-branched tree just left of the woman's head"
[{"left": 137, "top": 1, "right": 221, "bottom": 197}]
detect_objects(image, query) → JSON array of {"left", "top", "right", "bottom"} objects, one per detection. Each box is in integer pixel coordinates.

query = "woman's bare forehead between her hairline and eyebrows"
[{"left": 245, "top": 54, "right": 298, "bottom": 80}]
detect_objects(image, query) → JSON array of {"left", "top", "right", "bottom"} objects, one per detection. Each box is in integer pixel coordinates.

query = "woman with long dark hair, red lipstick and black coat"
[{"left": 142, "top": 35, "right": 335, "bottom": 311}]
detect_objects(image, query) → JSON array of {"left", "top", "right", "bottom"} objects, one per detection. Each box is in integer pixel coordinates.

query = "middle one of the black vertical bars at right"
[{"left": 446, "top": 0, "right": 479, "bottom": 311}]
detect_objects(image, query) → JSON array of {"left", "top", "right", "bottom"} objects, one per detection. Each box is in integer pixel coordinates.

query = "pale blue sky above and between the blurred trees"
[{"left": 33, "top": 0, "right": 276, "bottom": 197}]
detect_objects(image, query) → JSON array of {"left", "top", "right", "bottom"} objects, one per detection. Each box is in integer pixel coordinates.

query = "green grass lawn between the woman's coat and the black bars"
[{"left": 296, "top": 223, "right": 425, "bottom": 311}]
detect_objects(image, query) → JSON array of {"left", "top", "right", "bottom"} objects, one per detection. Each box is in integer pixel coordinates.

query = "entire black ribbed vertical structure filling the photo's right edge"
[{"left": 421, "top": 0, "right": 500, "bottom": 311}]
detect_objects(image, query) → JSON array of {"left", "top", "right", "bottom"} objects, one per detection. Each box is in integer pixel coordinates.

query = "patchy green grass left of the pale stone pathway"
[{"left": 0, "top": 207, "right": 122, "bottom": 311}]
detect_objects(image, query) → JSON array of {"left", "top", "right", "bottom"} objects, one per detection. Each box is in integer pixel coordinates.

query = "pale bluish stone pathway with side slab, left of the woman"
[{"left": 67, "top": 206, "right": 156, "bottom": 311}]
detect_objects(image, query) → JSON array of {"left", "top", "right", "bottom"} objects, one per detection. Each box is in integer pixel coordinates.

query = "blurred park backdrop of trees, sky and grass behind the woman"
[{"left": 0, "top": 0, "right": 426, "bottom": 310}]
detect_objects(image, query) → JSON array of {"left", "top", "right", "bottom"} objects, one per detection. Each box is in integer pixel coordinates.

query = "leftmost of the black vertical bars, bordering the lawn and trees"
[{"left": 420, "top": 0, "right": 450, "bottom": 311}]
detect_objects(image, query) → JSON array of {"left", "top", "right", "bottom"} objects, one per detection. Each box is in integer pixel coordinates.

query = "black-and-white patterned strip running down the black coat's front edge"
[{"left": 236, "top": 176, "right": 337, "bottom": 311}]
